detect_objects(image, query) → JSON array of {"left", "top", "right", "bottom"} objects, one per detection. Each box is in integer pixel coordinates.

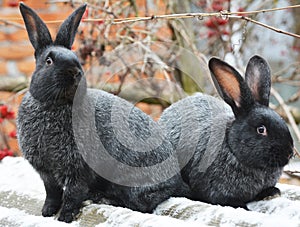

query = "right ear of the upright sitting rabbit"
[{"left": 54, "top": 4, "right": 86, "bottom": 49}]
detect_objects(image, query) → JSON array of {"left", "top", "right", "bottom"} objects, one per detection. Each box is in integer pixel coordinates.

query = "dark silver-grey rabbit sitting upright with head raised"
[{"left": 17, "top": 3, "right": 187, "bottom": 222}]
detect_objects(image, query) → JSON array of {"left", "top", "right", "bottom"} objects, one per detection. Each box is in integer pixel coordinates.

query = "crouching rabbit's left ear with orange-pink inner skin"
[{"left": 208, "top": 58, "right": 254, "bottom": 116}]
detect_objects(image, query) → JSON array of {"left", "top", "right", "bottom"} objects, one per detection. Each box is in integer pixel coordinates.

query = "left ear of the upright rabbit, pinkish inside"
[{"left": 20, "top": 3, "right": 52, "bottom": 54}]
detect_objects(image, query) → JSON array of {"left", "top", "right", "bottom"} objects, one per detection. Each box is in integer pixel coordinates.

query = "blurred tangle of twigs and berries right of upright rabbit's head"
[{"left": 71, "top": 0, "right": 300, "bottom": 147}]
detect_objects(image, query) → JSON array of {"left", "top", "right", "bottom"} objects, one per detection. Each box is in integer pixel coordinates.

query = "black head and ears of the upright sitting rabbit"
[{"left": 20, "top": 3, "right": 86, "bottom": 104}]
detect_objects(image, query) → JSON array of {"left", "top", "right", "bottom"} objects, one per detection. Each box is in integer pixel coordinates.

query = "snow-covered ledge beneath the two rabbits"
[{"left": 0, "top": 157, "right": 300, "bottom": 227}]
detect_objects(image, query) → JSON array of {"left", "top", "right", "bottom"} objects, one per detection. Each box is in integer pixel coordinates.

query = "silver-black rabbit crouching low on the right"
[{"left": 160, "top": 56, "right": 293, "bottom": 209}]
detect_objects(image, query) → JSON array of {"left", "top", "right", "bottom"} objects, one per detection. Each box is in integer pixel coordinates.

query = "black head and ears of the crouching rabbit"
[{"left": 209, "top": 56, "right": 293, "bottom": 168}]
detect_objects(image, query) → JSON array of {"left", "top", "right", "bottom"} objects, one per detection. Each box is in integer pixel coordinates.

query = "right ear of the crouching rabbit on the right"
[{"left": 245, "top": 55, "right": 271, "bottom": 106}]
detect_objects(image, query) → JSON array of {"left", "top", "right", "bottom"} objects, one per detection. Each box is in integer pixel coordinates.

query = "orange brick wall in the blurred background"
[{"left": 0, "top": 0, "right": 166, "bottom": 155}]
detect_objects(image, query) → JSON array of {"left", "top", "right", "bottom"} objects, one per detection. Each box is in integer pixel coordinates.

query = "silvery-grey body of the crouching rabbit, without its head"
[{"left": 160, "top": 93, "right": 282, "bottom": 205}]
